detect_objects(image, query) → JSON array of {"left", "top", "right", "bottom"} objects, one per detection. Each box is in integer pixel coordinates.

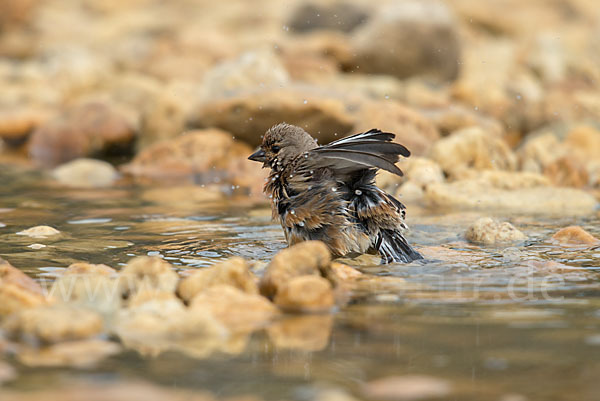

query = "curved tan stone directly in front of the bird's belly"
[{"left": 259, "top": 241, "right": 331, "bottom": 298}]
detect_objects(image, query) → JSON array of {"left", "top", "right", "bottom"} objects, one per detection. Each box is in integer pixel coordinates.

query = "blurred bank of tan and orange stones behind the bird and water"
[{"left": 0, "top": 0, "right": 600, "bottom": 194}]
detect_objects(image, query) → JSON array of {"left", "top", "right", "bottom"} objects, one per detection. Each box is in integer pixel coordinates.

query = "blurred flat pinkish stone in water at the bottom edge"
[{"left": 363, "top": 375, "right": 452, "bottom": 401}]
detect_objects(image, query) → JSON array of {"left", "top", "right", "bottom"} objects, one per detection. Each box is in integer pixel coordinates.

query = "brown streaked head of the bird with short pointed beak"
[{"left": 248, "top": 123, "right": 318, "bottom": 169}]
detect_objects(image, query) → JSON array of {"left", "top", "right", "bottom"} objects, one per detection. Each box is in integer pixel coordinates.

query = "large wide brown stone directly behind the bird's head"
[{"left": 192, "top": 84, "right": 354, "bottom": 146}]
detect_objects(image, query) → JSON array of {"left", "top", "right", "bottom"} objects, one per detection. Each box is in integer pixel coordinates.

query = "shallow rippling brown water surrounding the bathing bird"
[{"left": 0, "top": 167, "right": 600, "bottom": 400}]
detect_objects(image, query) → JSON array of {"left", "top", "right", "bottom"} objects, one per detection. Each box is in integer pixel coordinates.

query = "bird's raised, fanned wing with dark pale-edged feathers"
[{"left": 306, "top": 129, "right": 410, "bottom": 175}]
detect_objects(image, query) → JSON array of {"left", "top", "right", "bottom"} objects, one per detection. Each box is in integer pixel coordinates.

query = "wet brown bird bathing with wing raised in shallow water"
[{"left": 248, "top": 123, "right": 423, "bottom": 263}]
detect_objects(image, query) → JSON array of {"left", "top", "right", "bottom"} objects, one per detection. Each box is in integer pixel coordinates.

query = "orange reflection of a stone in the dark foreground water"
[{"left": 267, "top": 314, "right": 333, "bottom": 352}]
